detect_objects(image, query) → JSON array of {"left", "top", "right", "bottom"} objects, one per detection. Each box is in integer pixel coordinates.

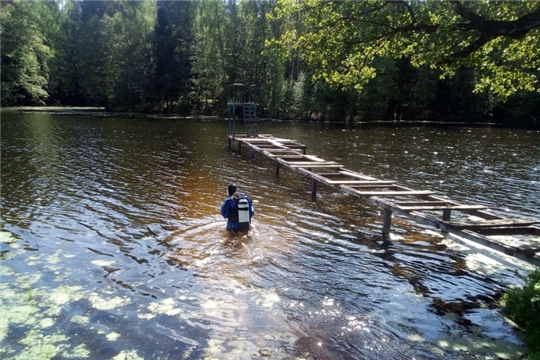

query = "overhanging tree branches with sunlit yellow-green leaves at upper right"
[{"left": 273, "top": 0, "right": 540, "bottom": 97}]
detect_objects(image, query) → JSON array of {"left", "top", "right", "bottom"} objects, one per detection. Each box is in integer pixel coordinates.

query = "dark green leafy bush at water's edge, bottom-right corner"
[{"left": 503, "top": 269, "right": 540, "bottom": 360}]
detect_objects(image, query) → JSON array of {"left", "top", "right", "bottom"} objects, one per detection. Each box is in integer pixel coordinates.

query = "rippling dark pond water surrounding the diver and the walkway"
[{"left": 0, "top": 114, "right": 540, "bottom": 359}]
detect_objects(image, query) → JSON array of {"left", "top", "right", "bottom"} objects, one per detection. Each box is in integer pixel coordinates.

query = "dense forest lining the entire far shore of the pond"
[{"left": 0, "top": 0, "right": 540, "bottom": 126}]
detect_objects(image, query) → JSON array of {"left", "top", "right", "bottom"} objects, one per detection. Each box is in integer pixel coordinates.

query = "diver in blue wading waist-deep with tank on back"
[{"left": 221, "top": 184, "right": 255, "bottom": 233}]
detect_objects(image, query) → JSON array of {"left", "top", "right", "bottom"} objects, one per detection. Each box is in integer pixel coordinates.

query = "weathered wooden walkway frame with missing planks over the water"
[{"left": 228, "top": 134, "right": 540, "bottom": 266}]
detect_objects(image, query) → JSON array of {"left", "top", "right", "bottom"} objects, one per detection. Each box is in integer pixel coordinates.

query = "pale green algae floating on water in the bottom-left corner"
[{"left": 0, "top": 231, "right": 141, "bottom": 360}]
